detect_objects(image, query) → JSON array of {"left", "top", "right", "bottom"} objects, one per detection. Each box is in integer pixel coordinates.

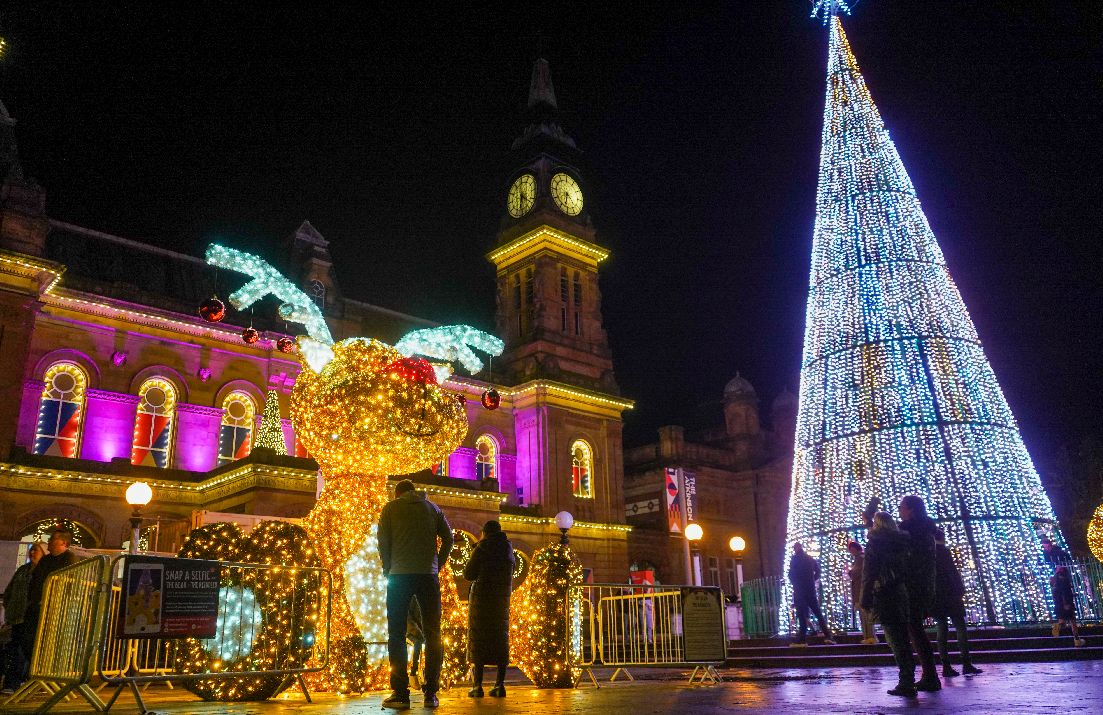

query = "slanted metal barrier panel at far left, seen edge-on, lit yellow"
[{"left": 4, "top": 556, "right": 108, "bottom": 713}]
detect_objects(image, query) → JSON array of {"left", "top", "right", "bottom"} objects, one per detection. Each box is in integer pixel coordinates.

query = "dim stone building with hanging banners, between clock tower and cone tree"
[{"left": 624, "top": 375, "right": 796, "bottom": 595}]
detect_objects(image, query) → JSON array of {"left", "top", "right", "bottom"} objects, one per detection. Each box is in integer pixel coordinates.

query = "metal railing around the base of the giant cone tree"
[{"left": 741, "top": 558, "right": 1103, "bottom": 638}]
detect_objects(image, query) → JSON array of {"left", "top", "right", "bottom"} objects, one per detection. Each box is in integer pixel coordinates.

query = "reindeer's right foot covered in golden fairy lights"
[{"left": 510, "top": 544, "right": 582, "bottom": 687}]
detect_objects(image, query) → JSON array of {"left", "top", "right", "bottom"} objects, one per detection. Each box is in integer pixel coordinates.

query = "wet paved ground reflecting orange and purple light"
[{"left": 2, "top": 661, "right": 1103, "bottom": 715}]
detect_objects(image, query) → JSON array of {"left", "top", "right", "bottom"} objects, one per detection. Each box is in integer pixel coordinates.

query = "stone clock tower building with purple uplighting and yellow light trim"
[{"left": 0, "top": 61, "right": 632, "bottom": 581}]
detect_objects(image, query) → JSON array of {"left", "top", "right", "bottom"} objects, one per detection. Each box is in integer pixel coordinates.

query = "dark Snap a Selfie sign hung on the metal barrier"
[{"left": 115, "top": 556, "right": 219, "bottom": 638}]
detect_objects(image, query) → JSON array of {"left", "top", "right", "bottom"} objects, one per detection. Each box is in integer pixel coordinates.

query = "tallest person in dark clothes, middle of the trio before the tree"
[{"left": 900, "top": 494, "right": 942, "bottom": 692}]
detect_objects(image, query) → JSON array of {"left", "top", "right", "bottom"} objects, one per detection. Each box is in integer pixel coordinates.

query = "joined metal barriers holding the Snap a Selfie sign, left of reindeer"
[{"left": 0, "top": 556, "right": 333, "bottom": 713}]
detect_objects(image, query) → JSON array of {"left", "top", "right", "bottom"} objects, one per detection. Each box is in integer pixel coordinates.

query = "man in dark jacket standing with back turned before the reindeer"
[{"left": 376, "top": 479, "right": 452, "bottom": 709}]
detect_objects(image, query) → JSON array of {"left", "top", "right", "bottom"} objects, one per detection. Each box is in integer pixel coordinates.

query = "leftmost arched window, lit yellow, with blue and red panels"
[{"left": 33, "top": 363, "right": 88, "bottom": 458}]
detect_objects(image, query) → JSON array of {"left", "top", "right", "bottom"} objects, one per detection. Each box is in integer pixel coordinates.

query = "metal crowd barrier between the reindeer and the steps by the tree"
[{"left": 567, "top": 584, "right": 727, "bottom": 687}]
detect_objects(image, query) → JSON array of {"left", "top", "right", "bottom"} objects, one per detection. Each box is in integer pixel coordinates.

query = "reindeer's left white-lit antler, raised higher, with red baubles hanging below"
[{"left": 206, "top": 244, "right": 333, "bottom": 345}]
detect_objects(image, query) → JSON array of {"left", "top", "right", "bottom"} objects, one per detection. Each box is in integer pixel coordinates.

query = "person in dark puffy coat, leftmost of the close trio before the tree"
[{"left": 859, "top": 512, "right": 915, "bottom": 697}]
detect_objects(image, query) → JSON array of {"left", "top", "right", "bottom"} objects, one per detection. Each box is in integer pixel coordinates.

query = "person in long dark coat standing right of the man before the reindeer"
[{"left": 463, "top": 521, "right": 516, "bottom": 697}]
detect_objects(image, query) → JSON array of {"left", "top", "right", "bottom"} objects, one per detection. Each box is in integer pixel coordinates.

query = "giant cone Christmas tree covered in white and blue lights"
[{"left": 785, "top": 12, "right": 1060, "bottom": 626}]
